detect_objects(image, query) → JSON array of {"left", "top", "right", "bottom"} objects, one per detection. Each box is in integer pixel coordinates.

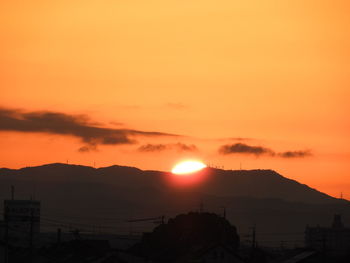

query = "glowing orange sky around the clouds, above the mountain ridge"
[{"left": 0, "top": 0, "right": 350, "bottom": 198}]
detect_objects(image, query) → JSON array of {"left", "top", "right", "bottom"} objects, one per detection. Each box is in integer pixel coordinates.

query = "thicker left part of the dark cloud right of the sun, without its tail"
[{"left": 219, "top": 143, "right": 274, "bottom": 156}]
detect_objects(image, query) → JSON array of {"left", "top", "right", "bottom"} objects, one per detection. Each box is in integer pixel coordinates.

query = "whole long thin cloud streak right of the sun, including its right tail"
[{"left": 219, "top": 143, "right": 312, "bottom": 158}]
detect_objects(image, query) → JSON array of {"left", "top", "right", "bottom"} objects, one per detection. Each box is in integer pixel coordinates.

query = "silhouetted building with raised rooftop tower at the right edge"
[{"left": 305, "top": 215, "right": 350, "bottom": 256}]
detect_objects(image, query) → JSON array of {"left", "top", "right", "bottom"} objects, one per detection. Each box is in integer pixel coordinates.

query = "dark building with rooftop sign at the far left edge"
[{"left": 4, "top": 200, "right": 40, "bottom": 247}]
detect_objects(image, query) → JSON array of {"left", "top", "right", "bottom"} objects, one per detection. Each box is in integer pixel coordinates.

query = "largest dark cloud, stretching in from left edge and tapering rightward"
[{"left": 0, "top": 108, "right": 177, "bottom": 152}]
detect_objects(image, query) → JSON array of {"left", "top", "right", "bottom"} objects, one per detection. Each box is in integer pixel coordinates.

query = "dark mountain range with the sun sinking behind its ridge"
[{"left": 0, "top": 163, "right": 350, "bottom": 249}]
